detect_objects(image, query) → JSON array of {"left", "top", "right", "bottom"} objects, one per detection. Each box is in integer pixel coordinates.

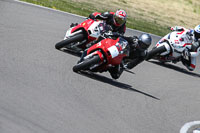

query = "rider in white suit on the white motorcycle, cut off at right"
[{"left": 171, "top": 25, "right": 200, "bottom": 71}]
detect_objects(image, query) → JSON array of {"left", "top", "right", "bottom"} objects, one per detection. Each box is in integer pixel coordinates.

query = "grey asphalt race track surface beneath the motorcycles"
[{"left": 0, "top": 0, "right": 200, "bottom": 133}]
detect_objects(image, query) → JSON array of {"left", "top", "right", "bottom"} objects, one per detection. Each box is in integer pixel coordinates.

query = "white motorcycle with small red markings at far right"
[{"left": 146, "top": 31, "right": 200, "bottom": 63}]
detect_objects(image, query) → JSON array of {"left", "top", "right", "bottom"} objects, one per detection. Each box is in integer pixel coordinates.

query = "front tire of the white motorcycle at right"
[{"left": 145, "top": 46, "right": 166, "bottom": 61}]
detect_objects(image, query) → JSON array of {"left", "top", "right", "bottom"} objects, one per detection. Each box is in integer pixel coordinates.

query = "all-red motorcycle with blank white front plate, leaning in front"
[{"left": 73, "top": 34, "right": 130, "bottom": 75}]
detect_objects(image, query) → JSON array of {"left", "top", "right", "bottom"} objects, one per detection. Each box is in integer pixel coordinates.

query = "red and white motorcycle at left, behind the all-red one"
[{"left": 55, "top": 19, "right": 109, "bottom": 52}]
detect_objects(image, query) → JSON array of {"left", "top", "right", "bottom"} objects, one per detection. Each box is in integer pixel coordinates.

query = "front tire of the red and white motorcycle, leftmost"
[{"left": 55, "top": 33, "right": 84, "bottom": 49}]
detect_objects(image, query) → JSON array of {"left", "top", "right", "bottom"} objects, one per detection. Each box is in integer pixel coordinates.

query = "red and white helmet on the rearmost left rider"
[{"left": 113, "top": 9, "right": 127, "bottom": 26}]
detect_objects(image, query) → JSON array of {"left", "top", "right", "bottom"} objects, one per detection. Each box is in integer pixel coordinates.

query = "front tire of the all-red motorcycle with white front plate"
[{"left": 73, "top": 55, "right": 101, "bottom": 72}]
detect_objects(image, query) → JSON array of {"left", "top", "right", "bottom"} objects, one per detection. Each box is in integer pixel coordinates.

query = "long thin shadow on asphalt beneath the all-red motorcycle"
[{"left": 78, "top": 71, "right": 160, "bottom": 100}]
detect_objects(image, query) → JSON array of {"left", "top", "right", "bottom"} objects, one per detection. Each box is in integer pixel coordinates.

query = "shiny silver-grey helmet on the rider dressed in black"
[{"left": 138, "top": 33, "right": 152, "bottom": 51}]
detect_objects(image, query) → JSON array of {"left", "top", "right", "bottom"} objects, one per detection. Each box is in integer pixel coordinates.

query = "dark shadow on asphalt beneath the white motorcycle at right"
[{"left": 148, "top": 61, "right": 200, "bottom": 78}]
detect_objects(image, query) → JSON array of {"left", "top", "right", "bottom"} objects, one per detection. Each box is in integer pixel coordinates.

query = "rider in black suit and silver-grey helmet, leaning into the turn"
[{"left": 109, "top": 33, "right": 152, "bottom": 79}]
